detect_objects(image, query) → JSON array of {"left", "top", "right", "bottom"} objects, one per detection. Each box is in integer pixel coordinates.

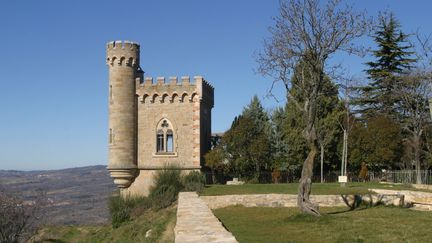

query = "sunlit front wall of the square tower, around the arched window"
[{"left": 138, "top": 79, "right": 199, "bottom": 169}]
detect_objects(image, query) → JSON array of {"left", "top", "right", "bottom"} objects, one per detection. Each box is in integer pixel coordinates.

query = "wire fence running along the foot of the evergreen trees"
[{"left": 204, "top": 170, "right": 432, "bottom": 185}]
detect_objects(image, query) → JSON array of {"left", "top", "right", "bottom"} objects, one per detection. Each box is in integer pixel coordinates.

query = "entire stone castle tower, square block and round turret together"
[{"left": 107, "top": 41, "right": 214, "bottom": 195}]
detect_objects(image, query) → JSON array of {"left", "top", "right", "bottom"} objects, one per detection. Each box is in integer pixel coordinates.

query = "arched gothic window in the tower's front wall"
[{"left": 156, "top": 119, "right": 175, "bottom": 154}]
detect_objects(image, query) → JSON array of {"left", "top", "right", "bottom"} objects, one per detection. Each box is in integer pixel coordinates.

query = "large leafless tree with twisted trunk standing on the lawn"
[{"left": 257, "top": 0, "right": 370, "bottom": 215}]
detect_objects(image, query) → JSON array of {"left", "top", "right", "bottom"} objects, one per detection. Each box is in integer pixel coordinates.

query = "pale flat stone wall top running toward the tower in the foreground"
[{"left": 174, "top": 192, "right": 237, "bottom": 243}]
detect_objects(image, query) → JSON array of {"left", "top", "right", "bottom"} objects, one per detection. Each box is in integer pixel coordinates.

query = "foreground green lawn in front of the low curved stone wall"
[{"left": 214, "top": 206, "right": 432, "bottom": 243}]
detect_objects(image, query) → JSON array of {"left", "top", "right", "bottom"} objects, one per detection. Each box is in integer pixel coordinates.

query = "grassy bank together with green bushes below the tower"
[{"left": 33, "top": 168, "right": 204, "bottom": 243}]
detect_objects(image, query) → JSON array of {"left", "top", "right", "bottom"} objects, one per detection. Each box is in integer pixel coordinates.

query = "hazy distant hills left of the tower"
[{"left": 0, "top": 165, "right": 116, "bottom": 224}]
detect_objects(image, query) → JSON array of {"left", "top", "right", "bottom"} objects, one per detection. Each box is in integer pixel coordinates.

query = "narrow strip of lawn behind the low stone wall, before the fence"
[{"left": 200, "top": 182, "right": 424, "bottom": 196}]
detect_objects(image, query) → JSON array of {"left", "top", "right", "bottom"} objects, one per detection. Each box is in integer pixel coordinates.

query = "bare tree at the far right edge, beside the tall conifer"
[{"left": 395, "top": 30, "right": 432, "bottom": 184}]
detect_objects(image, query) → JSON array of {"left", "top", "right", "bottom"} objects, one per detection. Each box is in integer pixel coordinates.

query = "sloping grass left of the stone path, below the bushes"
[{"left": 31, "top": 205, "right": 177, "bottom": 243}]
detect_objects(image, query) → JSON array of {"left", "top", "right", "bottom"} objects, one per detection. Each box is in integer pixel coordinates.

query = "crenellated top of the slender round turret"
[{"left": 106, "top": 41, "right": 140, "bottom": 67}]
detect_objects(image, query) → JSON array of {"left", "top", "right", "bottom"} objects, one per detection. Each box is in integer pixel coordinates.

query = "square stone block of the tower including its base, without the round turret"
[{"left": 122, "top": 77, "right": 213, "bottom": 195}]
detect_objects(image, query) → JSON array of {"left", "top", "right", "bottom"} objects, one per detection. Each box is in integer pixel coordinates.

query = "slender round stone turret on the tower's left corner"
[{"left": 106, "top": 41, "right": 140, "bottom": 188}]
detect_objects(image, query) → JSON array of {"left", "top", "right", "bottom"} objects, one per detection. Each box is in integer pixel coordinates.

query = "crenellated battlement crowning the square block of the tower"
[{"left": 137, "top": 76, "right": 214, "bottom": 106}]
